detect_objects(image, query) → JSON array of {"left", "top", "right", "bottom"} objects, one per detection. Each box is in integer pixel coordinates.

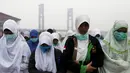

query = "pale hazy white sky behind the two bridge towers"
[{"left": 0, "top": 0, "right": 130, "bottom": 31}]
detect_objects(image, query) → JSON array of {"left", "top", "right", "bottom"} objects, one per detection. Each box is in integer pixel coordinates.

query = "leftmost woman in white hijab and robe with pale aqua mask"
[{"left": 0, "top": 19, "right": 31, "bottom": 73}]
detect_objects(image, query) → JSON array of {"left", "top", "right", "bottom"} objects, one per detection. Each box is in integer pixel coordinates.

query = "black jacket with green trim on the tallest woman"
[{"left": 60, "top": 35, "right": 104, "bottom": 73}]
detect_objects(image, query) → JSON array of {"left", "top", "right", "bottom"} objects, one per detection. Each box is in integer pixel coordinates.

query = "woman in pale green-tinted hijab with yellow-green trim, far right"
[{"left": 100, "top": 21, "right": 130, "bottom": 73}]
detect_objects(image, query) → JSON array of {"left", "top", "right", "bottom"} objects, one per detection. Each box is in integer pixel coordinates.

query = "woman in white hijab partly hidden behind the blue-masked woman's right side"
[{"left": 52, "top": 33, "right": 63, "bottom": 52}]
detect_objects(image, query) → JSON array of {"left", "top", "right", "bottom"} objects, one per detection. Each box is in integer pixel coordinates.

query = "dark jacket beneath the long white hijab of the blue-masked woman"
[{"left": 28, "top": 49, "right": 62, "bottom": 73}]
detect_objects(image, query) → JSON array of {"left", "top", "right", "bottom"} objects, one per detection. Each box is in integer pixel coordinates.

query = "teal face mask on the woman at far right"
[{"left": 114, "top": 31, "right": 127, "bottom": 41}]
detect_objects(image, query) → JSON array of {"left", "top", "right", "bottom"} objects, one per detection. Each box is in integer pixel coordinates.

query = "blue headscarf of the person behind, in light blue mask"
[{"left": 27, "top": 30, "right": 39, "bottom": 52}]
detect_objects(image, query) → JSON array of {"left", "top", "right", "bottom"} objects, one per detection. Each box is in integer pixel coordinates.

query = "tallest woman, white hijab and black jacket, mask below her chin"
[{"left": 61, "top": 15, "right": 104, "bottom": 73}]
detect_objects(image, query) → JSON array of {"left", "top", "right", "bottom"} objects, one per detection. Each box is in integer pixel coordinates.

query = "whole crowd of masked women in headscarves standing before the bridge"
[{"left": 0, "top": 15, "right": 130, "bottom": 73}]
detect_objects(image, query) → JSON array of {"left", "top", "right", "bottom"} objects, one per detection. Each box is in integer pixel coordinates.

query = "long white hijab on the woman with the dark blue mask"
[{"left": 35, "top": 32, "right": 57, "bottom": 73}]
